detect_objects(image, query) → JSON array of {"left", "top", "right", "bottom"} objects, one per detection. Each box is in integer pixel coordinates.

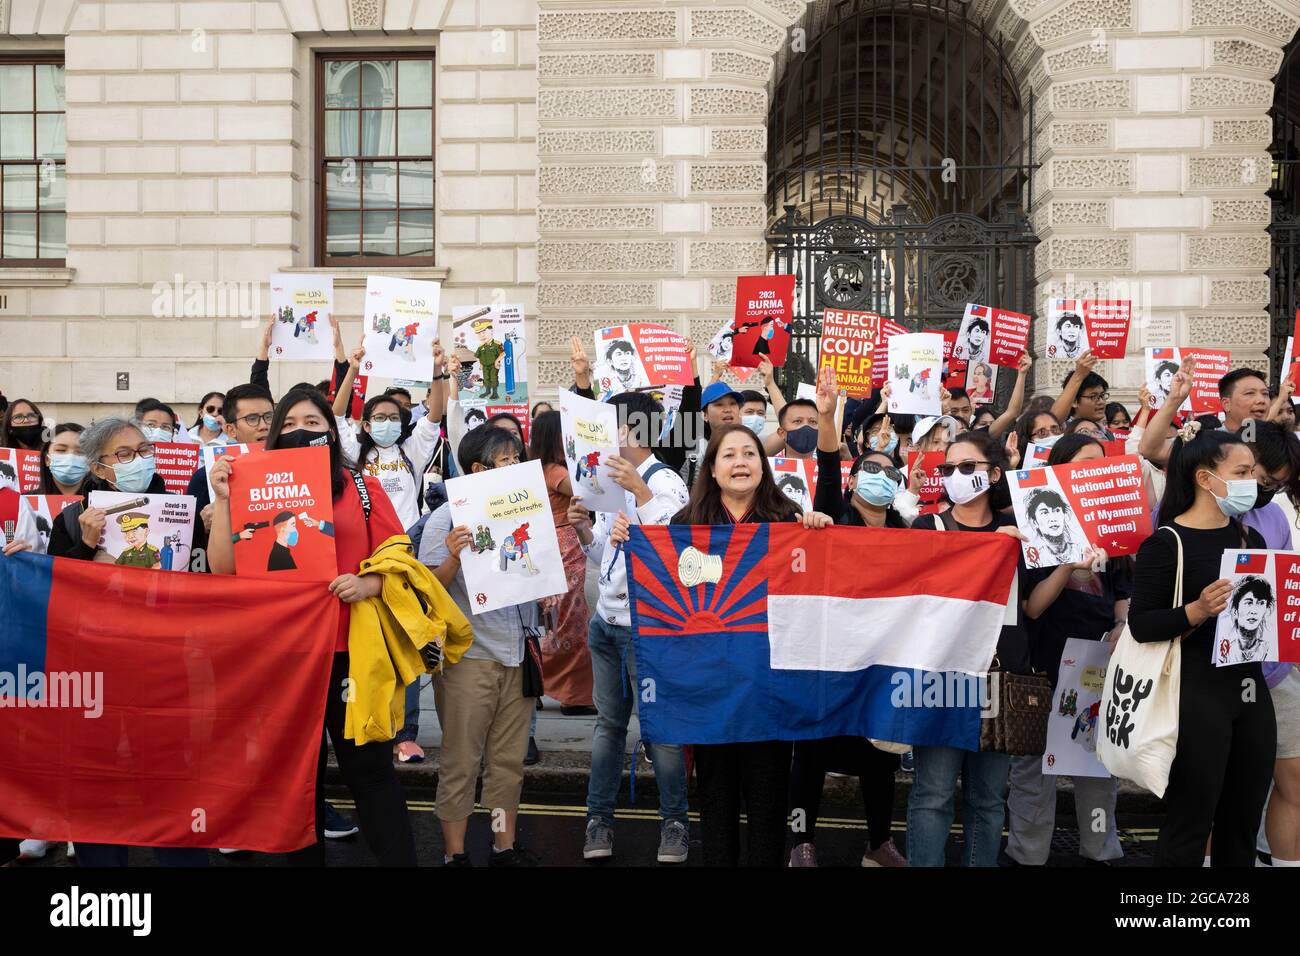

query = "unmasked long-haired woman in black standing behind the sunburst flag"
[{"left": 660, "top": 424, "right": 840, "bottom": 866}]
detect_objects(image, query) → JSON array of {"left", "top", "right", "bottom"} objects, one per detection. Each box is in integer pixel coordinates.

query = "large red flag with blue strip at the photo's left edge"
[{"left": 0, "top": 554, "right": 339, "bottom": 852}]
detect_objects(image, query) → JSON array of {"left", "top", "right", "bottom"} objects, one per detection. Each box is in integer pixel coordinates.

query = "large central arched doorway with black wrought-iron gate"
[{"left": 767, "top": 0, "right": 1037, "bottom": 392}]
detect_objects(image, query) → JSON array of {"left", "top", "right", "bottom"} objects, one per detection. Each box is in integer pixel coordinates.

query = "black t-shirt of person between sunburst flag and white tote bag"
[{"left": 1021, "top": 558, "right": 1132, "bottom": 687}]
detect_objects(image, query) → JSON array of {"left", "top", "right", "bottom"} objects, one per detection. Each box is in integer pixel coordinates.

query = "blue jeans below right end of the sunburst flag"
[{"left": 907, "top": 747, "right": 1011, "bottom": 866}]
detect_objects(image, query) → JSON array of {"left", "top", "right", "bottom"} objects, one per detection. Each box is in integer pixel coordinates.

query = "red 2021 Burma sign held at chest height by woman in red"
[{"left": 230, "top": 446, "right": 338, "bottom": 581}]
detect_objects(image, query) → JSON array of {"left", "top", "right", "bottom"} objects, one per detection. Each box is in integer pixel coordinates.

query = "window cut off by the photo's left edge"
[{"left": 0, "top": 53, "right": 68, "bottom": 268}]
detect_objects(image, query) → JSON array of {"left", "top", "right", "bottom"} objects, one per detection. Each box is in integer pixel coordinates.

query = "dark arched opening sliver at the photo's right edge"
[{"left": 1269, "top": 35, "right": 1300, "bottom": 381}]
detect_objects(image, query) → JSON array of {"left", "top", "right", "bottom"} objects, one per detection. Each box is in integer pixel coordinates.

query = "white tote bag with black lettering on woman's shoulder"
[{"left": 1097, "top": 524, "right": 1183, "bottom": 797}]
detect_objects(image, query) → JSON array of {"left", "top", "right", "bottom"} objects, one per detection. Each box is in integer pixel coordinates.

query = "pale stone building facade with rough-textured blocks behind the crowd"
[{"left": 0, "top": 0, "right": 1300, "bottom": 419}]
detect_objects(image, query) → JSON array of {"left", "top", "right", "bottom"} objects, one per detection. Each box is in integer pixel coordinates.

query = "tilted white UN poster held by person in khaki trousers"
[{"left": 446, "top": 460, "right": 568, "bottom": 614}]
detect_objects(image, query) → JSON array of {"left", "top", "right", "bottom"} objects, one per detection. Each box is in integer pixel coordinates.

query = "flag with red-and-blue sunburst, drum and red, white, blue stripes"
[{"left": 627, "top": 523, "right": 1019, "bottom": 750}]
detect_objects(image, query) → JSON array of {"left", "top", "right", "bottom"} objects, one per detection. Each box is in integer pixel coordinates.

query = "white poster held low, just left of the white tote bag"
[{"left": 1043, "top": 637, "right": 1115, "bottom": 777}]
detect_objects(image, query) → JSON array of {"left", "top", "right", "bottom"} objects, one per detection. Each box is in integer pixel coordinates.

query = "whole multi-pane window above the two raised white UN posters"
[{"left": 316, "top": 51, "right": 434, "bottom": 265}]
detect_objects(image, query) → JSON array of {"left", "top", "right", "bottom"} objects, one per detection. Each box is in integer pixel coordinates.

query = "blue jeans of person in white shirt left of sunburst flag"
[{"left": 586, "top": 618, "right": 686, "bottom": 823}]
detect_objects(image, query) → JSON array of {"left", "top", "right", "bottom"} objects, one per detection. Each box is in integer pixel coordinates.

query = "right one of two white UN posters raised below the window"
[{"left": 360, "top": 276, "right": 442, "bottom": 381}]
